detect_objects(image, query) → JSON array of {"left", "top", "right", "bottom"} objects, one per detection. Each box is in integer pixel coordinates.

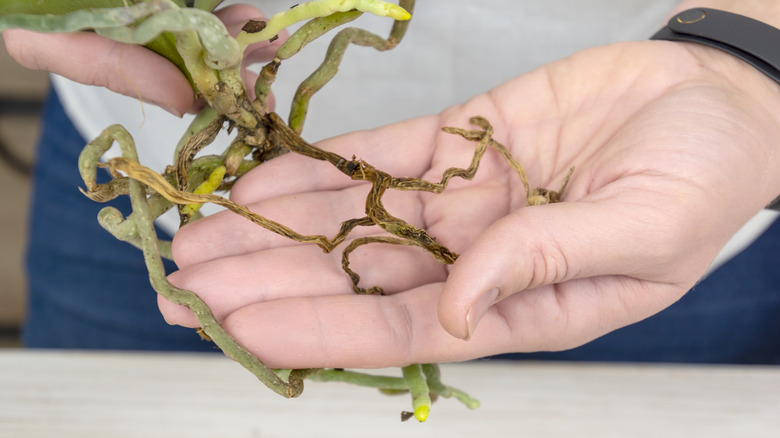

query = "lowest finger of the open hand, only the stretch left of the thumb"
[{"left": 223, "top": 283, "right": 501, "bottom": 368}]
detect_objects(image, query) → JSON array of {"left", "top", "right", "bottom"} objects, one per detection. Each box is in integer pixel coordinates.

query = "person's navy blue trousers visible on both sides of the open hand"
[{"left": 24, "top": 88, "right": 780, "bottom": 364}]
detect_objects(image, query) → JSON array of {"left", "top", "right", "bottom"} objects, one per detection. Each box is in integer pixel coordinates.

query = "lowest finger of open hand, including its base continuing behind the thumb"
[{"left": 193, "top": 279, "right": 679, "bottom": 368}]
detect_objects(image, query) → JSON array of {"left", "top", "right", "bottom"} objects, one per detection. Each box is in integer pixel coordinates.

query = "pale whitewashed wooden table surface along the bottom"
[{"left": 0, "top": 350, "right": 780, "bottom": 438}]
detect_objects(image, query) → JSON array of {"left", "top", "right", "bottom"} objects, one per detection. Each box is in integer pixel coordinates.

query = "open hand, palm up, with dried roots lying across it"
[{"left": 160, "top": 42, "right": 780, "bottom": 368}]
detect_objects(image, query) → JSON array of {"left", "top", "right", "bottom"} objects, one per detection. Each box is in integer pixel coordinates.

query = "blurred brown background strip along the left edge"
[{"left": 0, "top": 36, "right": 49, "bottom": 348}]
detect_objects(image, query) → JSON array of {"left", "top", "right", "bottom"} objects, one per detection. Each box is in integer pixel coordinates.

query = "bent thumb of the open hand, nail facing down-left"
[{"left": 438, "top": 201, "right": 717, "bottom": 339}]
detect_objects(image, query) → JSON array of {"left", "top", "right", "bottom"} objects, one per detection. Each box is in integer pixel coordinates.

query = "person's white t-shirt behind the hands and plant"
[{"left": 53, "top": 0, "right": 776, "bottom": 270}]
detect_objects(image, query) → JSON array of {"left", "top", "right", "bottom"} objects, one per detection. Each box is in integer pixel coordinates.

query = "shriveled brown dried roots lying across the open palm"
[{"left": 103, "top": 113, "right": 574, "bottom": 293}]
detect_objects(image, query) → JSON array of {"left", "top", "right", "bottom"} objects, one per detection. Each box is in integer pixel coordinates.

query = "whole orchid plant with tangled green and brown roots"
[{"left": 0, "top": 0, "right": 568, "bottom": 421}]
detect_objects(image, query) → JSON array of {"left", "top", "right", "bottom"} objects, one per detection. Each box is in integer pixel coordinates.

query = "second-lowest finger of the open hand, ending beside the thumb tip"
[{"left": 159, "top": 238, "right": 446, "bottom": 327}]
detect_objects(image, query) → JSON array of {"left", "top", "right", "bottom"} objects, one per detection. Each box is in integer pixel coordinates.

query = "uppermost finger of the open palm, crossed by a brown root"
[{"left": 231, "top": 116, "right": 442, "bottom": 204}]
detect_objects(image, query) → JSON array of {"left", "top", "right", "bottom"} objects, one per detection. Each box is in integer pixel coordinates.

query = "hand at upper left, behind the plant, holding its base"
[{"left": 2, "top": 5, "right": 284, "bottom": 116}]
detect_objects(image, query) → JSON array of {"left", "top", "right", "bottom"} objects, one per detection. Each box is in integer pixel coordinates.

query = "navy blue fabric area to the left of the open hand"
[{"left": 22, "top": 92, "right": 215, "bottom": 351}]
